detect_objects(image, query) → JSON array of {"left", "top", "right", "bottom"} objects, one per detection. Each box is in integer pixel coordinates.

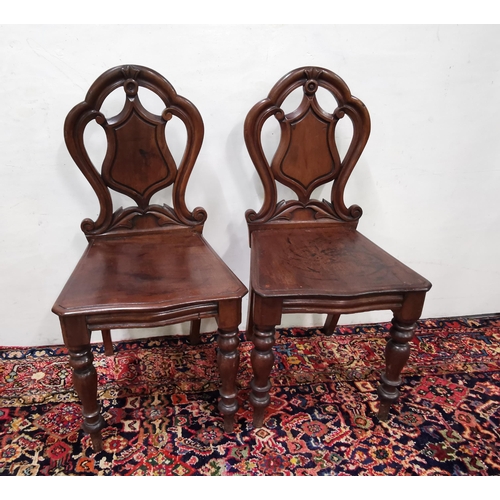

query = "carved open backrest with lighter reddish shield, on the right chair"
[{"left": 244, "top": 67, "right": 370, "bottom": 232}]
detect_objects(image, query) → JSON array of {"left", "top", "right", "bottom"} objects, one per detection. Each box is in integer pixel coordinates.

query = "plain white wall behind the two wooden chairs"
[{"left": 0, "top": 25, "right": 500, "bottom": 346}]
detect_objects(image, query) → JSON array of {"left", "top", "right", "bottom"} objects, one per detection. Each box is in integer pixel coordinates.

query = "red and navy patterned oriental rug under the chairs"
[{"left": 0, "top": 314, "right": 500, "bottom": 476}]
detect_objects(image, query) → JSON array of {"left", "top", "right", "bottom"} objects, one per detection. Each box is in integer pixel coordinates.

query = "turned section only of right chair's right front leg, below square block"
[{"left": 378, "top": 318, "right": 417, "bottom": 420}]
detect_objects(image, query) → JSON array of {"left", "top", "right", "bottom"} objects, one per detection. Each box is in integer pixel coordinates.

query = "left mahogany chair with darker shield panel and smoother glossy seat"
[{"left": 53, "top": 66, "right": 247, "bottom": 452}]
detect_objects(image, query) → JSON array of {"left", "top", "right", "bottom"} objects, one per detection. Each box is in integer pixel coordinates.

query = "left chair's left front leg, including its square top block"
[{"left": 61, "top": 317, "right": 106, "bottom": 453}]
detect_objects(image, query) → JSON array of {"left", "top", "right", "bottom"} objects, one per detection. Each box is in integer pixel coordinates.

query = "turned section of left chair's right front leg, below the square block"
[{"left": 217, "top": 327, "right": 240, "bottom": 432}]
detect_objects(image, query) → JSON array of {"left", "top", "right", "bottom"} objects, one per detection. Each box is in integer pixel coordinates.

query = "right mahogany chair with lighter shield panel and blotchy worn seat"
[{"left": 244, "top": 67, "right": 431, "bottom": 427}]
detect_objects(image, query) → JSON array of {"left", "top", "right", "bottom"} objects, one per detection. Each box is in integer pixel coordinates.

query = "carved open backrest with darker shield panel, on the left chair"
[{"left": 64, "top": 65, "right": 207, "bottom": 239}]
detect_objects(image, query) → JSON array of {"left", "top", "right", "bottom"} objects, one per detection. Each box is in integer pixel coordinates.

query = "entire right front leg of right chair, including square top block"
[{"left": 377, "top": 292, "right": 425, "bottom": 420}]
